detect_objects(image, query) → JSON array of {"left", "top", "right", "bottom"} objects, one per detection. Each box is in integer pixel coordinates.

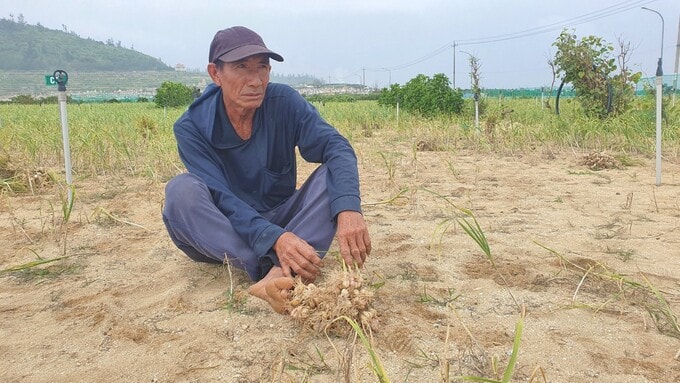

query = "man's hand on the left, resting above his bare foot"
[{"left": 273, "top": 232, "right": 322, "bottom": 282}]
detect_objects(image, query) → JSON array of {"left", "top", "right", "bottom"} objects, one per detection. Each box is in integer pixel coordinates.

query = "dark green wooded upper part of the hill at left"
[{"left": 0, "top": 18, "right": 173, "bottom": 73}]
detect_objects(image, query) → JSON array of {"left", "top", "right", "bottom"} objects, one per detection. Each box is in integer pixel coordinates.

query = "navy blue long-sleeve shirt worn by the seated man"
[{"left": 174, "top": 83, "right": 361, "bottom": 255}]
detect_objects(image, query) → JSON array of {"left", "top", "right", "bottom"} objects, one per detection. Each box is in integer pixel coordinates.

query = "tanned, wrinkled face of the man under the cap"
[{"left": 208, "top": 54, "right": 271, "bottom": 110}]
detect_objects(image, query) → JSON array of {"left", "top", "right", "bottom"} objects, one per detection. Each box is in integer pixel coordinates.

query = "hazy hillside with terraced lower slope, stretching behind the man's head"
[{"left": 0, "top": 15, "right": 356, "bottom": 101}]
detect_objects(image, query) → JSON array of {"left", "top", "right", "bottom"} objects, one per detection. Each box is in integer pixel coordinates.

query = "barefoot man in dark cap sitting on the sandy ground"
[{"left": 163, "top": 26, "right": 371, "bottom": 313}]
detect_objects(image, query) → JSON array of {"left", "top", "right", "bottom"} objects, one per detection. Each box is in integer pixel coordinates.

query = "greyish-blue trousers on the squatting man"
[{"left": 163, "top": 165, "right": 337, "bottom": 281}]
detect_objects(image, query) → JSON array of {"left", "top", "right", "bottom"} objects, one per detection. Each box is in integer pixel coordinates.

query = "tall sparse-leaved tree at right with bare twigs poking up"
[{"left": 553, "top": 30, "right": 641, "bottom": 118}]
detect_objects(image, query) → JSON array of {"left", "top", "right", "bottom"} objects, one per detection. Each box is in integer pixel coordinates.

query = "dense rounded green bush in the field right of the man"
[{"left": 378, "top": 73, "right": 463, "bottom": 117}]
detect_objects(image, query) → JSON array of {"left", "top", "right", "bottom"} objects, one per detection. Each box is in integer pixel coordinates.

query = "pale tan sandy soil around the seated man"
[{"left": 0, "top": 137, "right": 680, "bottom": 383}]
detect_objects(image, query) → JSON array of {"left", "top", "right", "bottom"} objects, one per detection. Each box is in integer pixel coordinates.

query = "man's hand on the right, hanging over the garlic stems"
[{"left": 337, "top": 210, "right": 371, "bottom": 267}]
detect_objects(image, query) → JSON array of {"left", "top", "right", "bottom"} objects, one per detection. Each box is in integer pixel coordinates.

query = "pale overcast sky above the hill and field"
[{"left": 0, "top": 0, "right": 680, "bottom": 88}]
